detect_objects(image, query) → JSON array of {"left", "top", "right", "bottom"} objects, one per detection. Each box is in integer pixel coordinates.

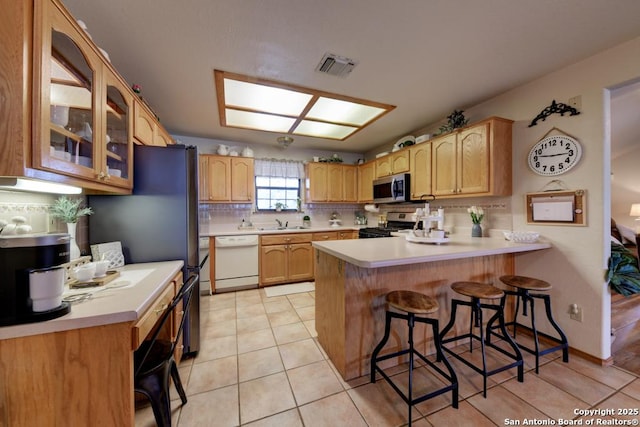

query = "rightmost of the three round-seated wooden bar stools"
[{"left": 487, "top": 276, "right": 569, "bottom": 374}]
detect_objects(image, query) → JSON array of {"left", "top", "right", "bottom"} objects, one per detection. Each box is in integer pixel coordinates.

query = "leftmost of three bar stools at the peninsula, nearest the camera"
[{"left": 371, "top": 291, "right": 458, "bottom": 425}]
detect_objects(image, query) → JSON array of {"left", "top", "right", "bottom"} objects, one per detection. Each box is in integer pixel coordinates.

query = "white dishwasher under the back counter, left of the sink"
[{"left": 214, "top": 234, "right": 258, "bottom": 292}]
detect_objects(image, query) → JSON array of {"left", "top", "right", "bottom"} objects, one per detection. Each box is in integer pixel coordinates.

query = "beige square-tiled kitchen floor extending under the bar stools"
[{"left": 136, "top": 290, "right": 640, "bottom": 427}]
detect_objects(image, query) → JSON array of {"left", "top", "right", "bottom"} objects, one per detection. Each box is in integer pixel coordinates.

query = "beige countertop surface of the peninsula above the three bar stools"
[{"left": 313, "top": 234, "right": 551, "bottom": 268}]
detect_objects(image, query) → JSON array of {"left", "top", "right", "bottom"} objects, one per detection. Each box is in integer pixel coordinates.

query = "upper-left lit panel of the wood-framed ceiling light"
[{"left": 224, "top": 79, "right": 312, "bottom": 116}]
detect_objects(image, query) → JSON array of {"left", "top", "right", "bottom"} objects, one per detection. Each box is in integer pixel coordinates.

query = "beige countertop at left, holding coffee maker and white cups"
[{"left": 0, "top": 261, "right": 183, "bottom": 339}]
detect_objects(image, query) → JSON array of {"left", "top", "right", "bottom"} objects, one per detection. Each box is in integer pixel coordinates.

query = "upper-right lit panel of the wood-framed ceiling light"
[{"left": 306, "top": 97, "right": 385, "bottom": 126}]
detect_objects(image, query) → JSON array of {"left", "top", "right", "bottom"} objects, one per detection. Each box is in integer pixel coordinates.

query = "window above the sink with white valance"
[{"left": 256, "top": 176, "right": 300, "bottom": 211}]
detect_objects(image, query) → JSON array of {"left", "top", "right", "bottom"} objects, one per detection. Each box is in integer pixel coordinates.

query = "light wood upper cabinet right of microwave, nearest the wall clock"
[{"left": 431, "top": 117, "right": 513, "bottom": 197}]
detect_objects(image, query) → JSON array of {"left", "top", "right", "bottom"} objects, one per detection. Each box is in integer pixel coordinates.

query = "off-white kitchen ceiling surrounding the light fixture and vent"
[{"left": 62, "top": 0, "right": 640, "bottom": 152}]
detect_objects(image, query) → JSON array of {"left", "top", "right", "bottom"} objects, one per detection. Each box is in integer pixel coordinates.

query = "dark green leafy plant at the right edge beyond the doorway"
[{"left": 606, "top": 242, "right": 640, "bottom": 297}]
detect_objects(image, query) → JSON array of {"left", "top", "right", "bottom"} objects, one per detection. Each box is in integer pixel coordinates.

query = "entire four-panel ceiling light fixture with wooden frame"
[{"left": 214, "top": 70, "right": 396, "bottom": 145}]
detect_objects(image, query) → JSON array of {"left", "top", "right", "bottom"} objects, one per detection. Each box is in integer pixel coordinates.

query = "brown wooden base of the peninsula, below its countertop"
[{"left": 315, "top": 251, "right": 514, "bottom": 380}]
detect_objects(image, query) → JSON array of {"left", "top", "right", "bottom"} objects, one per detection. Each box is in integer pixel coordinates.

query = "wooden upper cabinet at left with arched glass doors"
[{"left": 0, "top": 0, "right": 175, "bottom": 194}]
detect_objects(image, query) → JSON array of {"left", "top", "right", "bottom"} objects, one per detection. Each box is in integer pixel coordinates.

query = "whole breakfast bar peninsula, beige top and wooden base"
[{"left": 313, "top": 235, "right": 551, "bottom": 380}]
